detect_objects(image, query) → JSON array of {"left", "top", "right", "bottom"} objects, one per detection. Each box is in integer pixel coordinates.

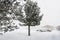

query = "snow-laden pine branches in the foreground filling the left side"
[{"left": 0, "top": 0, "right": 22, "bottom": 32}]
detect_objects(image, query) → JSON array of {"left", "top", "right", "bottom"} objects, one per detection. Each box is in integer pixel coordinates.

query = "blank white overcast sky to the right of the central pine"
[{"left": 17, "top": 0, "right": 60, "bottom": 26}]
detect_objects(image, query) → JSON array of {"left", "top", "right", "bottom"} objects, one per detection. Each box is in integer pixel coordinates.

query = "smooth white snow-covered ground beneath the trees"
[{"left": 0, "top": 27, "right": 60, "bottom": 40}]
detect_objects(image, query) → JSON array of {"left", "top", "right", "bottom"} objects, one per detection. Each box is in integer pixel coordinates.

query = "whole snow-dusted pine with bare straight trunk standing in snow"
[{"left": 19, "top": 0, "right": 43, "bottom": 36}]
